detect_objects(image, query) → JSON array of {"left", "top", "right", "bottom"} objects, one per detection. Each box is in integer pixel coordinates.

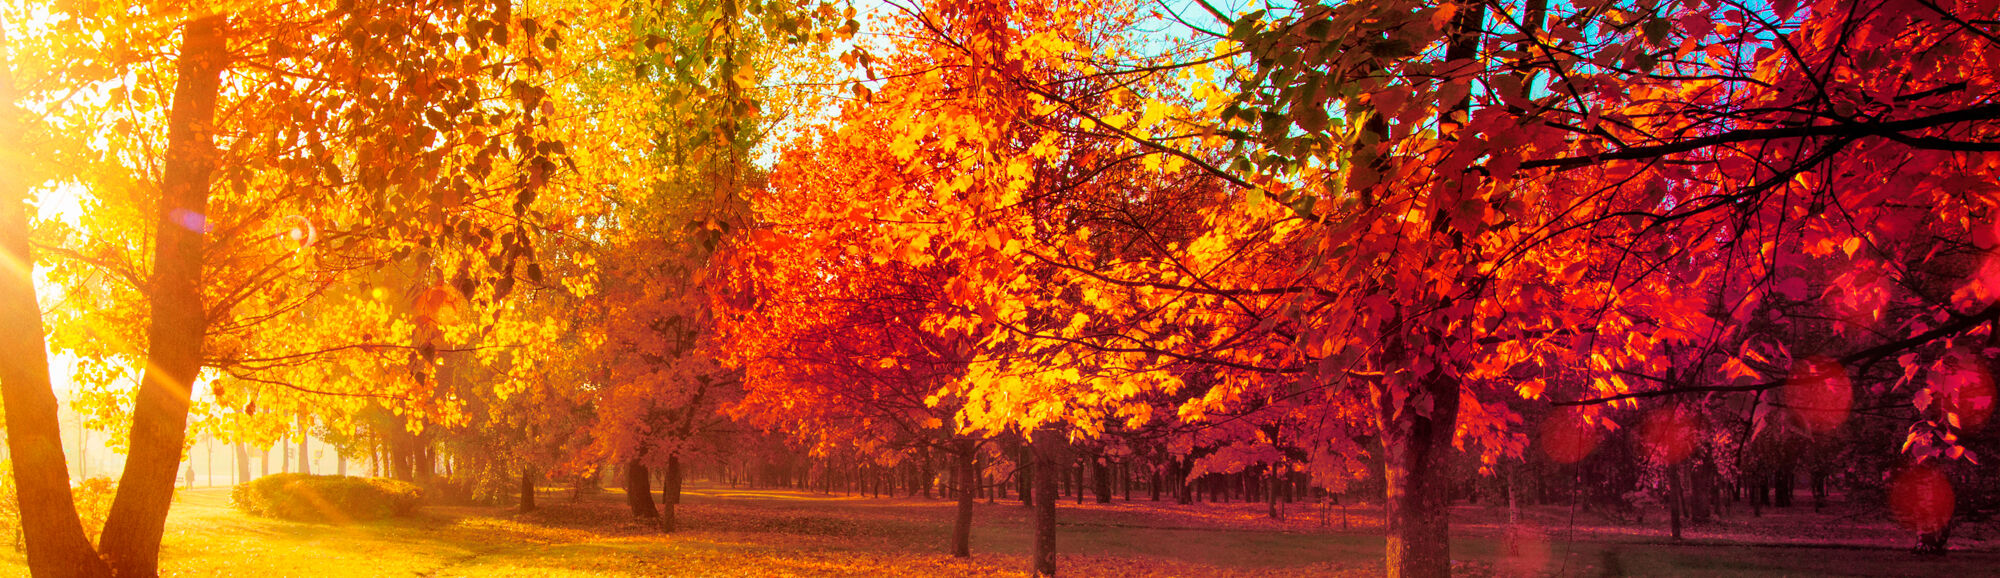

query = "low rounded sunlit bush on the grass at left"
[{"left": 230, "top": 474, "right": 424, "bottom": 524}]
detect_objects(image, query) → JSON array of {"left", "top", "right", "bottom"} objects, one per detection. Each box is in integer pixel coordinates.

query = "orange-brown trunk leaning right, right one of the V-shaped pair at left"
[{"left": 100, "top": 14, "right": 228, "bottom": 576}]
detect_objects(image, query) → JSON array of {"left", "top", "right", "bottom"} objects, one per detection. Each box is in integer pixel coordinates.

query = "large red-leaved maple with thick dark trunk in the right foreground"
[{"left": 752, "top": 2, "right": 1990, "bottom": 576}]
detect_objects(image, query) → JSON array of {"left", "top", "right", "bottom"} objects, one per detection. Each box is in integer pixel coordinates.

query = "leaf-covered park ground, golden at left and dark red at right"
[{"left": 0, "top": 484, "right": 2000, "bottom": 578}]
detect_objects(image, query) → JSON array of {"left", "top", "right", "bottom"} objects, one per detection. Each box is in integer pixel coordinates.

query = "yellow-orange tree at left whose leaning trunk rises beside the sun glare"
[{"left": 5, "top": 2, "right": 554, "bottom": 574}]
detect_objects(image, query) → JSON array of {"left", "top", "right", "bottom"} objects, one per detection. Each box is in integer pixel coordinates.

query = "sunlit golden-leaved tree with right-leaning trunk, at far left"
[{"left": 11, "top": 2, "right": 554, "bottom": 576}]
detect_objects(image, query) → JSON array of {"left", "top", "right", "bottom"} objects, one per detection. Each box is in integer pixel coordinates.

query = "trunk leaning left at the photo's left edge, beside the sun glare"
[{"left": 0, "top": 30, "right": 113, "bottom": 576}]
